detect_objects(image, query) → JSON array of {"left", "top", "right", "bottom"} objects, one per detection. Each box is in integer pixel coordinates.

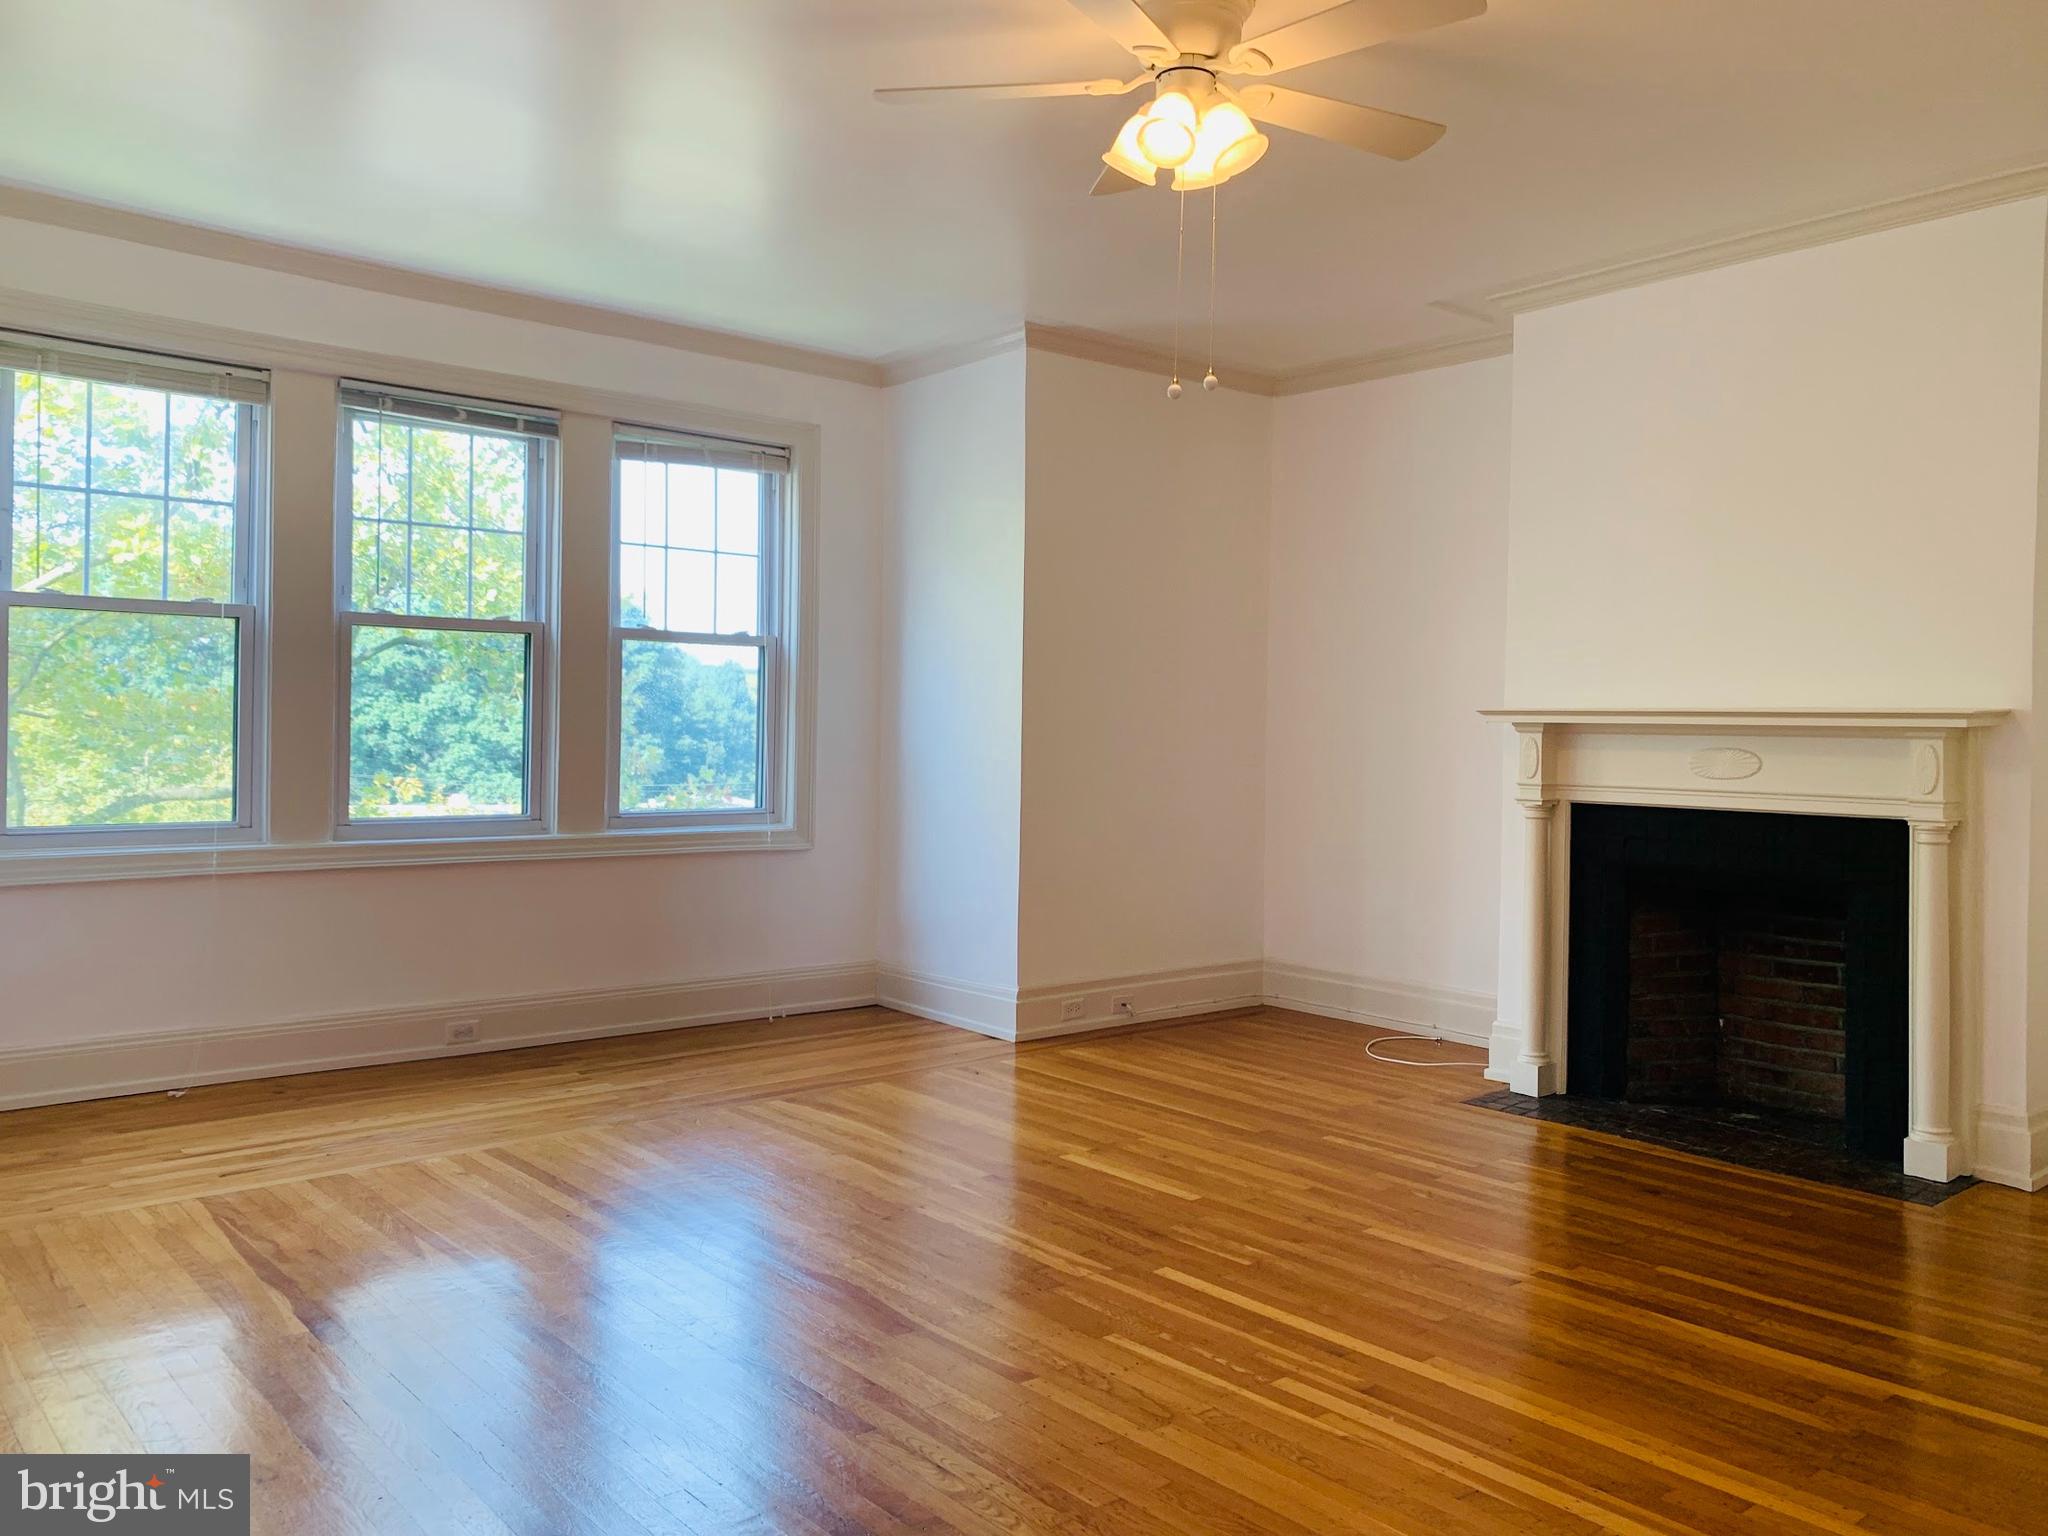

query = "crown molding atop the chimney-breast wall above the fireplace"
[{"left": 1458, "top": 164, "right": 2048, "bottom": 315}]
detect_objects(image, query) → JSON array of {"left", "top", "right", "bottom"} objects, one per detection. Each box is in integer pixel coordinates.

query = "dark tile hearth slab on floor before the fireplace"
[{"left": 1466, "top": 1090, "right": 1976, "bottom": 1206}]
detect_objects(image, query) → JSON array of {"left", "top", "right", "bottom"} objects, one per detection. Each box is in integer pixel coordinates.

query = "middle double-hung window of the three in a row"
[{"left": 336, "top": 383, "right": 555, "bottom": 838}]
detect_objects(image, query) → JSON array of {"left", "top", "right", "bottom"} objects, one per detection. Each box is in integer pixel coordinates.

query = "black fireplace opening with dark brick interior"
[{"left": 1567, "top": 805, "right": 1907, "bottom": 1167}]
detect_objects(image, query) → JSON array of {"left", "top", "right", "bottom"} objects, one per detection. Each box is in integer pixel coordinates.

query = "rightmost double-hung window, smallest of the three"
[{"left": 610, "top": 428, "right": 795, "bottom": 827}]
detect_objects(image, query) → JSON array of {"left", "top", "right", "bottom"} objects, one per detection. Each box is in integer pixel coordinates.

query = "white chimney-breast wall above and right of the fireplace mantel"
[{"left": 1503, "top": 199, "right": 2048, "bottom": 1146}]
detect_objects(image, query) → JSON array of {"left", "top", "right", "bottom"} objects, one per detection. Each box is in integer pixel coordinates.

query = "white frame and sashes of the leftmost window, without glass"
[{"left": 0, "top": 334, "right": 268, "bottom": 858}]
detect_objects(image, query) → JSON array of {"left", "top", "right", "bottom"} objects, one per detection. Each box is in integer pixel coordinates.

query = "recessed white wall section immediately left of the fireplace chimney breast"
[{"left": 1266, "top": 358, "right": 1513, "bottom": 1011}]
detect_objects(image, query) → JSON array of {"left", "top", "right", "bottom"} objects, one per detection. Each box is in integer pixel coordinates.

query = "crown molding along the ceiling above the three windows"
[{"left": 0, "top": 184, "right": 883, "bottom": 385}]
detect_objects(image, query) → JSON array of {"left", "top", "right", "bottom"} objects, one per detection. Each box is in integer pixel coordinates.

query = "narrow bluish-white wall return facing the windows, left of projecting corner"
[{"left": 879, "top": 350, "right": 1024, "bottom": 991}]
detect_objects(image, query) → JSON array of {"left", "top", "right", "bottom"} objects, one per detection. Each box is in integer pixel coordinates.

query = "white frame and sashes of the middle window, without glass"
[{"left": 334, "top": 379, "right": 559, "bottom": 842}]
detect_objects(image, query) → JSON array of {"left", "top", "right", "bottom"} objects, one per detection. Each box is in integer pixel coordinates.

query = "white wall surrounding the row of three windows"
[{"left": 0, "top": 221, "right": 883, "bottom": 1049}]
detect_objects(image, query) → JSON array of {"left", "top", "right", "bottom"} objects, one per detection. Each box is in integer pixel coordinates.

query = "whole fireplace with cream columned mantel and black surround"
[{"left": 1481, "top": 709, "right": 2007, "bottom": 1184}]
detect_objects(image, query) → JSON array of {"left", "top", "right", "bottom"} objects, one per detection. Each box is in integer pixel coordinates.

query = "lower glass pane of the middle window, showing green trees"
[{"left": 348, "top": 625, "right": 526, "bottom": 821}]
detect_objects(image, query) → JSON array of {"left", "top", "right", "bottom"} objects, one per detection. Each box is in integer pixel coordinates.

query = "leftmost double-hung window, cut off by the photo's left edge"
[{"left": 0, "top": 334, "right": 268, "bottom": 852}]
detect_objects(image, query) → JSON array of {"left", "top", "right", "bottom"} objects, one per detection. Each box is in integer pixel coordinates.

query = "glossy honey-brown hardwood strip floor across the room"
[{"left": 0, "top": 1010, "right": 2048, "bottom": 1536}]
